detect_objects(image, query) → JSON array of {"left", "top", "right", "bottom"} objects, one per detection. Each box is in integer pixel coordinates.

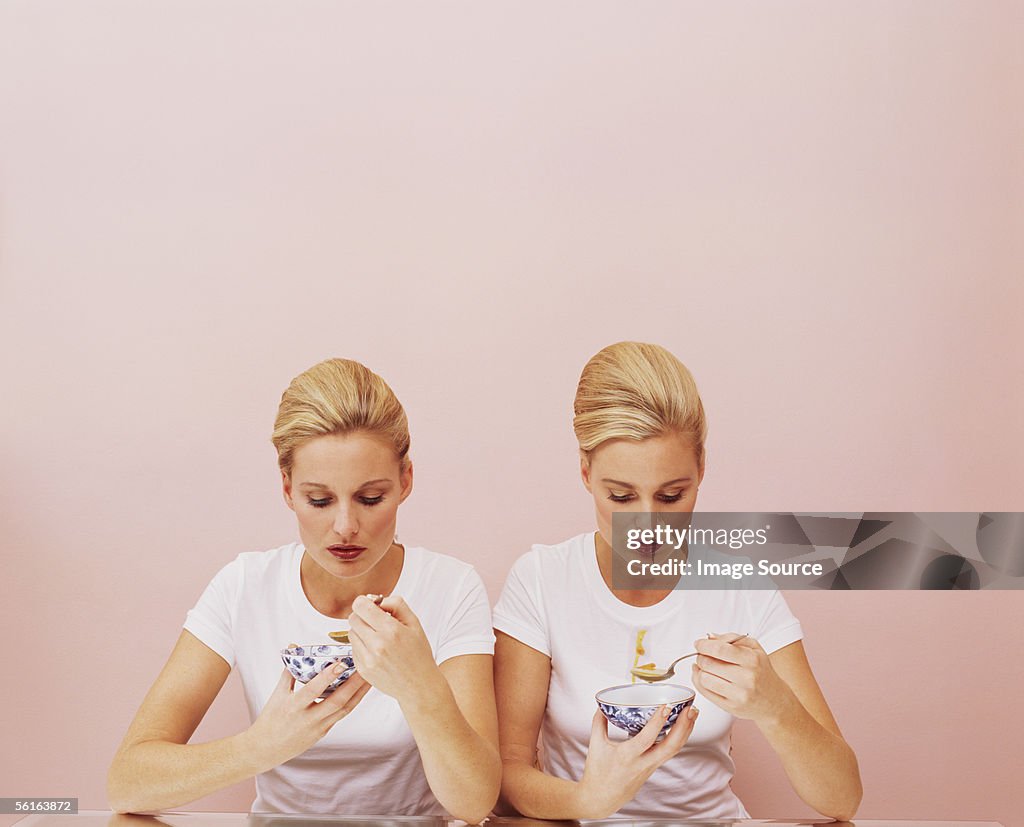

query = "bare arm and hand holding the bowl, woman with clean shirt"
[{"left": 106, "top": 630, "right": 369, "bottom": 813}]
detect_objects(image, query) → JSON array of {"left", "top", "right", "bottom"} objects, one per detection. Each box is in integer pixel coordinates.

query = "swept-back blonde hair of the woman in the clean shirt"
[{"left": 270, "top": 359, "right": 410, "bottom": 474}]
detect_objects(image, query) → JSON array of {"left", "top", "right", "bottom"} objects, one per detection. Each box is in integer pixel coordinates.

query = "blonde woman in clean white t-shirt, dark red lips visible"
[{"left": 109, "top": 359, "right": 501, "bottom": 823}]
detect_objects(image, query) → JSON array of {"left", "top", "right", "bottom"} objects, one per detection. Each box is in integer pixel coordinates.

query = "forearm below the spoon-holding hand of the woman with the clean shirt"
[{"left": 399, "top": 670, "right": 502, "bottom": 824}]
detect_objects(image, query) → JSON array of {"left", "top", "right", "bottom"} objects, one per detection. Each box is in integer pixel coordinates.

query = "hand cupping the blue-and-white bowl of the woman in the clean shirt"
[{"left": 246, "top": 663, "right": 370, "bottom": 769}]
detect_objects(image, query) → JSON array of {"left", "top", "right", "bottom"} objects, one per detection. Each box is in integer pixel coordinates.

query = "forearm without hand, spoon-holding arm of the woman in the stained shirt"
[{"left": 758, "top": 697, "right": 863, "bottom": 821}]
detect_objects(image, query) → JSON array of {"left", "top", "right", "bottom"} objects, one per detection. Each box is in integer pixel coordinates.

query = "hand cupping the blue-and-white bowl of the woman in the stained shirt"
[{"left": 580, "top": 705, "right": 699, "bottom": 819}]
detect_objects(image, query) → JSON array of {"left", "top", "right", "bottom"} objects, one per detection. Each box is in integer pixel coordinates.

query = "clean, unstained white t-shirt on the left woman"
[{"left": 184, "top": 542, "right": 495, "bottom": 816}]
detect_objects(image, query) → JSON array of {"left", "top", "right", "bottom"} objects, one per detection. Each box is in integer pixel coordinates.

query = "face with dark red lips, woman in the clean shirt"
[{"left": 282, "top": 433, "right": 413, "bottom": 577}]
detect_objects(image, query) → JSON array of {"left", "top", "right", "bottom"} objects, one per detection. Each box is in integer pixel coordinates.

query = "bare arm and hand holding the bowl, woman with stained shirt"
[{"left": 495, "top": 632, "right": 696, "bottom": 819}]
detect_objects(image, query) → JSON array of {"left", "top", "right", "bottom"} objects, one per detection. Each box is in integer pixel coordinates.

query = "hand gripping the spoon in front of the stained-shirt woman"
[{"left": 692, "top": 634, "right": 796, "bottom": 722}]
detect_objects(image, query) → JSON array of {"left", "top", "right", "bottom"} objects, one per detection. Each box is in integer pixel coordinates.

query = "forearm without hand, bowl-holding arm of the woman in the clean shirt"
[{"left": 106, "top": 733, "right": 270, "bottom": 813}]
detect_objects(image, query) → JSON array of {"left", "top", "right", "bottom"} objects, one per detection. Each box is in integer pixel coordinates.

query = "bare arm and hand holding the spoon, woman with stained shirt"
[{"left": 693, "top": 640, "right": 863, "bottom": 821}]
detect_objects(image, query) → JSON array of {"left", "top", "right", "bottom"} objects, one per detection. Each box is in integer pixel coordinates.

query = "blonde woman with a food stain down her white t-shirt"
[{"left": 495, "top": 342, "right": 861, "bottom": 820}]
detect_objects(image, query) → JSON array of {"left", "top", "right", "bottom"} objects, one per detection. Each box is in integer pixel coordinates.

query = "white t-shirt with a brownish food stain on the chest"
[{"left": 494, "top": 533, "right": 803, "bottom": 819}]
